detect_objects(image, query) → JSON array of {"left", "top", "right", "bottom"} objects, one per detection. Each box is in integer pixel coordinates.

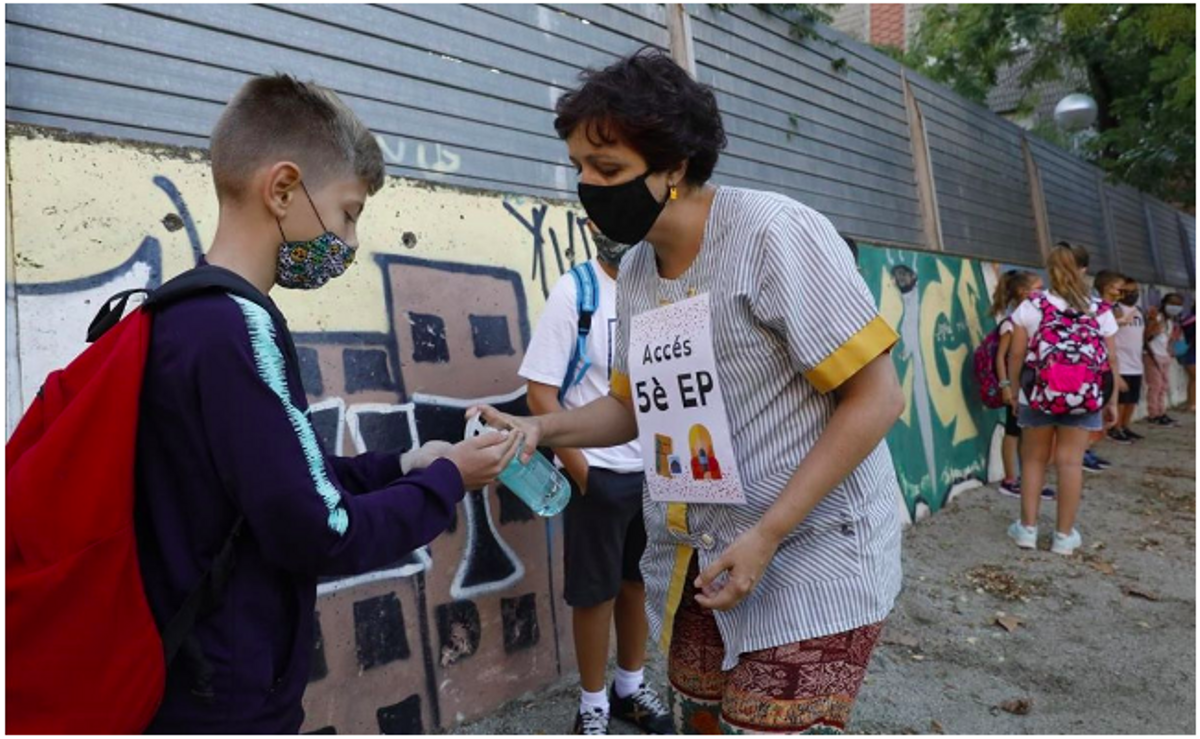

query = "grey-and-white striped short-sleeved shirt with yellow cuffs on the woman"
[{"left": 613, "top": 187, "right": 900, "bottom": 669}]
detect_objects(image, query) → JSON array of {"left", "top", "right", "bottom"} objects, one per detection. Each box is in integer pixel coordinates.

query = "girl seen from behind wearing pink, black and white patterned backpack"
[{"left": 1008, "top": 247, "right": 1118, "bottom": 554}]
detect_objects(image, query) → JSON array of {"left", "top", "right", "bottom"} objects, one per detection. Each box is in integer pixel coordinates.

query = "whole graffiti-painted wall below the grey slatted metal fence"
[{"left": 6, "top": 125, "right": 1182, "bottom": 733}]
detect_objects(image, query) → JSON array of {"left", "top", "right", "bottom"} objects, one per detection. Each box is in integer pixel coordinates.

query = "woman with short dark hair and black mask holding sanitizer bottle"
[{"left": 473, "top": 50, "right": 904, "bottom": 733}]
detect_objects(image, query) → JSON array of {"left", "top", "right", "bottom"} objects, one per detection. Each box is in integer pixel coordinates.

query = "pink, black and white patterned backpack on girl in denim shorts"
[{"left": 1025, "top": 293, "right": 1112, "bottom": 415}]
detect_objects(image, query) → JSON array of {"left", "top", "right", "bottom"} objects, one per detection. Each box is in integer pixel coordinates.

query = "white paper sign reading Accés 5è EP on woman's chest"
[{"left": 629, "top": 294, "right": 745, "bottom": 504}]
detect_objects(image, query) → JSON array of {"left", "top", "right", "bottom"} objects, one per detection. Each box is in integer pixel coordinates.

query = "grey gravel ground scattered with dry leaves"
[{"left": 455, "top": 414, "right": 1196, "bottom": 734}]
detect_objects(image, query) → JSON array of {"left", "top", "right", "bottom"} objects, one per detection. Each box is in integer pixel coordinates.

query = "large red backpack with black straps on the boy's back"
[{"left": 5, "top": 265, "right": 294, "bottom": 734}]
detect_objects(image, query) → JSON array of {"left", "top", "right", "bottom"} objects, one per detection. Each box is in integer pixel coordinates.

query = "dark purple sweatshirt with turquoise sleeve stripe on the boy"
[{"left": 136, "top": 294, "right": 463, "bottom": 734}]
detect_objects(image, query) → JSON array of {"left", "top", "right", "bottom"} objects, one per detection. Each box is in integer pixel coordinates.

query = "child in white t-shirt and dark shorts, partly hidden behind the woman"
[{"left": 520, "top": 229, "right": 671, "bottom": 733}]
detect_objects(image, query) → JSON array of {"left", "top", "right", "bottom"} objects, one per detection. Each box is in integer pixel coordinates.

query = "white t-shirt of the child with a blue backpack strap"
[{"left": 520, "top": 259, "right": 642, "bottom": 473}]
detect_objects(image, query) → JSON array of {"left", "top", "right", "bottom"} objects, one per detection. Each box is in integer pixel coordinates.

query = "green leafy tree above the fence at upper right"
[{"left": 888, "top": 4, "right": 1196, "bottom": 209}]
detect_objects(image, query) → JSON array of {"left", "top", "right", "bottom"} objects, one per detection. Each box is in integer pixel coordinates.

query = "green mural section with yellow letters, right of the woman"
[{"left": 858, "top": 245, "right": 1003, "bottom": 521}]
